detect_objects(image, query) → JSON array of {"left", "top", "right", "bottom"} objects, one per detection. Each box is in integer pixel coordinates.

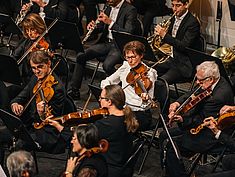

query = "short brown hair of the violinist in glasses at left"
[{"left": 28, "top": 50, "right": 52, "bottom": 64}]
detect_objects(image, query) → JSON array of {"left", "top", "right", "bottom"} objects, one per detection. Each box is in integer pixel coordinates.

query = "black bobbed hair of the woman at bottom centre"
[{"left": 74, "top": 123, "right": 99, "bottom": 149}]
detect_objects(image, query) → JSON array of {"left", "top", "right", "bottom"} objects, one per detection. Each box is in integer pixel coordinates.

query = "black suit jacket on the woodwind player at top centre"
[{"left": 94, "top": 2, "right": 140, "bottom": 42}]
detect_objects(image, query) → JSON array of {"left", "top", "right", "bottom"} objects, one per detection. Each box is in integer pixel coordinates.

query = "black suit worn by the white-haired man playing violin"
[{"left": 162, "top": 77, "right": 233, "bottom": 177}]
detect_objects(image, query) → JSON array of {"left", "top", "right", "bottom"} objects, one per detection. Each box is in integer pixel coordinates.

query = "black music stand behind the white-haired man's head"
[{"left": 186, "top": 48, "right": 232, "bottom": 86}]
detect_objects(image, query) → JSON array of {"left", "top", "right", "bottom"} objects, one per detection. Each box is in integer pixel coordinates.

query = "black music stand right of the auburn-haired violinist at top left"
[{"left": 45, "top": 18, "right": 84, "bottom": 53}]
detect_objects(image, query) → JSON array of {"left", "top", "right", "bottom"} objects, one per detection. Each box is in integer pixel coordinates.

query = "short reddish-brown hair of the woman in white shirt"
[{"left": 123, "top": 41, "right": 145, "bottom": 56}]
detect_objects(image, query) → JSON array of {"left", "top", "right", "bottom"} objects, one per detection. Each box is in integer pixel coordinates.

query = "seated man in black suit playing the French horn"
[{"left": 155, "top": 0, "right": 201, "bottom": 84}]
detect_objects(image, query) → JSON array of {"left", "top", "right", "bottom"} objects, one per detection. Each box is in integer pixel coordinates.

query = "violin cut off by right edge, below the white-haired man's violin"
[{"left": 190, "top": 111, "right": 235, "bottom": 135}]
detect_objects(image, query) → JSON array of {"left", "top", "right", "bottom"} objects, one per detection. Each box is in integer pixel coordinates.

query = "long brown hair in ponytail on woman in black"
[{"left": 104, "top": 85, "right": 139, "bottom": 133}]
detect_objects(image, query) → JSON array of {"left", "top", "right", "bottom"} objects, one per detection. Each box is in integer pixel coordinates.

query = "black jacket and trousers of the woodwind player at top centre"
[{"left": 71, "top": 2, "right": 138, "bottom": 90}]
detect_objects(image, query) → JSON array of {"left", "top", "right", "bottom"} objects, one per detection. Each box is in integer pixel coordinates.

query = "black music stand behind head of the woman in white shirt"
[{"left": 112, "top": 31, "right": 157, "bottom": 62}]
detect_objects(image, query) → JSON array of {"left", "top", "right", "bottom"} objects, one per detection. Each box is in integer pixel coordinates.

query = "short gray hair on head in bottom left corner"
[{"left": 7, "top": 151, "right": 35, "bottom": 177}]
